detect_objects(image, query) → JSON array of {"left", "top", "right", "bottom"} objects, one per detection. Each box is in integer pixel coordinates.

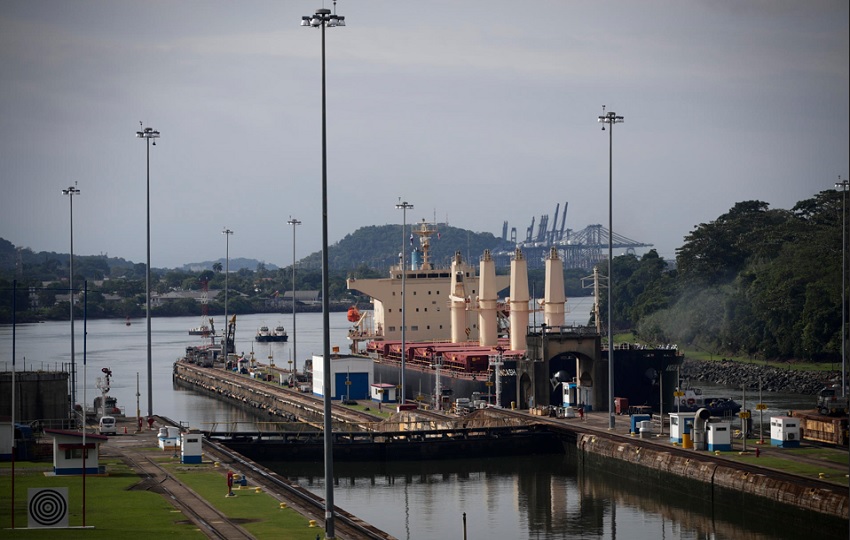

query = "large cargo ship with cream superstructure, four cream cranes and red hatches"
[{"left": 347, "top": 220, "right": 683, "bottom": 410}]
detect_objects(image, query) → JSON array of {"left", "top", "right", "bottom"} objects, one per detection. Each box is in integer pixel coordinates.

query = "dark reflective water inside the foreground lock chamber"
[{"left": 266, "top": 454, "right": 846, "bottom": 540}]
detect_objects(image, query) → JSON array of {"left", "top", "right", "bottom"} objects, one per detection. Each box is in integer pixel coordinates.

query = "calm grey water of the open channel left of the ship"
[{"left": 0, "top": 313, "right": 348, "bottom": 428}]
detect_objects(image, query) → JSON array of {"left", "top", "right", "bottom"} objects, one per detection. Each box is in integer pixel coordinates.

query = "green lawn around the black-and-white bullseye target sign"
[{"left": 0, "top": 459, "right": 206, "bottom": 540}]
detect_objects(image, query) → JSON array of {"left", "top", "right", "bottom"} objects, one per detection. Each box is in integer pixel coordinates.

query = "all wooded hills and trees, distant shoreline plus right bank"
[{"left": 0, "top": 190, "right": 844, "bottom": 360}]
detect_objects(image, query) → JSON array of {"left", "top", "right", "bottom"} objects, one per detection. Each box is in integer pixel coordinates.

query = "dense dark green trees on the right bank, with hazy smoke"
[{"left": 602, "top": 190, "right": 844, "bottom": 360}]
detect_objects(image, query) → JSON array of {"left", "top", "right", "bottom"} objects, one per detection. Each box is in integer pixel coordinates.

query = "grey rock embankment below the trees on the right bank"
[{"left": 681, "top": 359, "right": 841, "bottom": 395}]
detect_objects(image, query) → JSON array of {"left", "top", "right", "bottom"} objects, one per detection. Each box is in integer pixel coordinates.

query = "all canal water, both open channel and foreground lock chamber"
[{"left": 0, "top": 307, "right": 846, "bottom": 540}]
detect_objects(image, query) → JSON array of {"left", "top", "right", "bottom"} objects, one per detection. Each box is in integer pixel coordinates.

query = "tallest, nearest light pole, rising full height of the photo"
[{"left": 301, "top": 6, "right": 345, "bottom": 538}]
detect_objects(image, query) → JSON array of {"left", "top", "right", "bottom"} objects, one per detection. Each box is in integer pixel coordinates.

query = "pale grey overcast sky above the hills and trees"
[{"left": 0, "top": 0, "right": 850, "bottom": 268}]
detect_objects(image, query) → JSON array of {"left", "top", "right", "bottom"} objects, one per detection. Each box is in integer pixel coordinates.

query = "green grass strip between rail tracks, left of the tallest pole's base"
[{"left": 166, "top": 464, "right": 323, "bottom": 540}]
